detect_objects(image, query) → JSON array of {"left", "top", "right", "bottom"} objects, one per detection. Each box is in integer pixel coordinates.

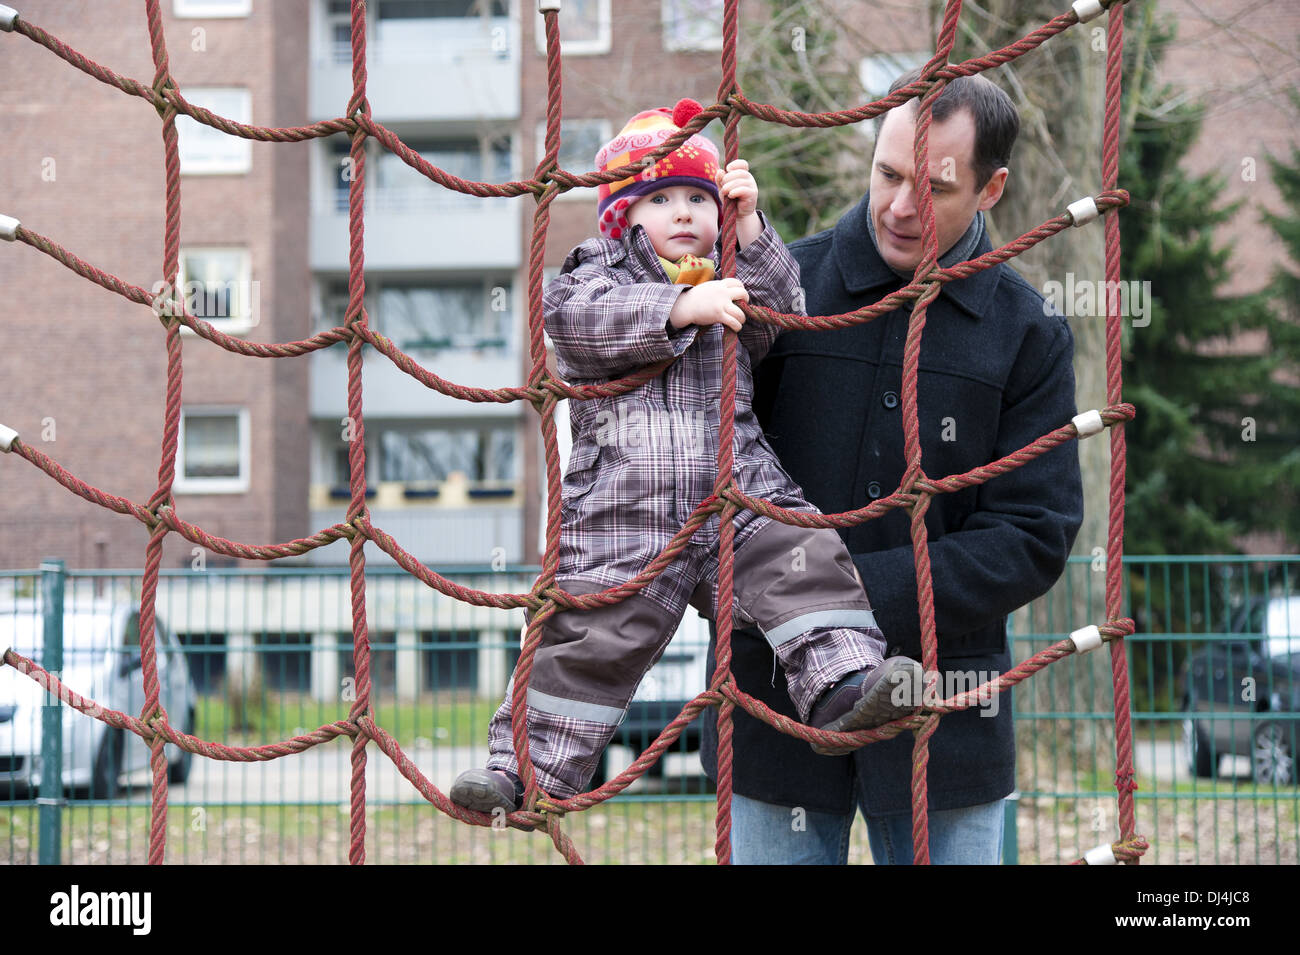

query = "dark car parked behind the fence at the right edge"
[{"left": 1183, "top": 595, "right": 1300, "bottom": 786}]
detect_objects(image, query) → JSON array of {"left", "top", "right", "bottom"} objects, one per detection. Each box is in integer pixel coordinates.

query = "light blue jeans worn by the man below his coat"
[{"left": 731, "top": 795, "right": 1005, "bottom": 865}]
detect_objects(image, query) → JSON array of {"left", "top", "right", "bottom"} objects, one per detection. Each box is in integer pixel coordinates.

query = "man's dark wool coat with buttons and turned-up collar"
[{"left": 702, "top": 196, "right": 1083, "bottom": 816}]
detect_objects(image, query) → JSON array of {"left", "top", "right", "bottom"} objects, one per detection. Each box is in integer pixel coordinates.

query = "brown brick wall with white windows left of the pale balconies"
[{"left": 0, "top": 0, "right": 311, "bottom": 568}]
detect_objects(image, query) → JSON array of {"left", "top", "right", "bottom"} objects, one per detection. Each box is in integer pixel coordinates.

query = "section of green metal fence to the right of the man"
[{"left": 1011, "top": 556, "right": 1300, "bottom": 864}]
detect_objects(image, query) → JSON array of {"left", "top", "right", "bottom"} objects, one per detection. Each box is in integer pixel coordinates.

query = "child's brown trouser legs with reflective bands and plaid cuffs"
[{"left": 488, "top": 521, "right": 884, "bottom": 798}]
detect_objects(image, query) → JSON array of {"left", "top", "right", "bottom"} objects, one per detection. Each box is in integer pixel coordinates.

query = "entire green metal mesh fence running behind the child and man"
[{"left": 0, "top": 557, "right": 1300, "bottom": 864}]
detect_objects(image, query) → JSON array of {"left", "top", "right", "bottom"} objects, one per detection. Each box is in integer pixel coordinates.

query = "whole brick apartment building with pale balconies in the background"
[{"left": 0, "top": 0, "right": 1300, "bottom": 568}]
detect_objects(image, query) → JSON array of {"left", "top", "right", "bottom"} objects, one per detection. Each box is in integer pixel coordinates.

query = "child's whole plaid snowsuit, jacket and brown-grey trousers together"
[{"left": 488, "top": 225, "right": 884, "bottom": 796}]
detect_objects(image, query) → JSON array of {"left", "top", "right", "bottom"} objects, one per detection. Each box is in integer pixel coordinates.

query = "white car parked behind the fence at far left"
[{"left": 0, "top": 600, "right": 196, "bottom": 799}]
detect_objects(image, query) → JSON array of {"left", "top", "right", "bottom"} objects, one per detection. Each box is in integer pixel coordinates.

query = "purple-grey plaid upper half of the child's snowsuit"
[{"left": 543, "top": 216, "right": 810, "bottom": 621}]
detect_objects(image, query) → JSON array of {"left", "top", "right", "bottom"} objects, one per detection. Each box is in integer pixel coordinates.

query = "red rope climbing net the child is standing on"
[{"left": 4, "top": 0, "right": 1147, "bottom": 864}]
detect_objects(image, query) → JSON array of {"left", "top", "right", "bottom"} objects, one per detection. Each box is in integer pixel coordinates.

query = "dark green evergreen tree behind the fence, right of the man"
[{"left": 1119, "top": 30, "right": 1300, "bottom": 554}]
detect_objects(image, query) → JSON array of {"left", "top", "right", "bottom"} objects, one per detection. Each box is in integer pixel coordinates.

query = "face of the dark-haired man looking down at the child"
[{"left": 871, "top": 104, "right": 1006, "bottom": 272}]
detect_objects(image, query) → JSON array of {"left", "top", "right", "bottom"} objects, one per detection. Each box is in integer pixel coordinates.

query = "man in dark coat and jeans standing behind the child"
[{"left": 703, "top": 73, "right": 1083, "bottom": 864}]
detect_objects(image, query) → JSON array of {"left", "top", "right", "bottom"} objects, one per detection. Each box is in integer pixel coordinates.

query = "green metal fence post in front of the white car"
[{"left": 36, "top": 559, "right": 66, "bottom": 865}]
